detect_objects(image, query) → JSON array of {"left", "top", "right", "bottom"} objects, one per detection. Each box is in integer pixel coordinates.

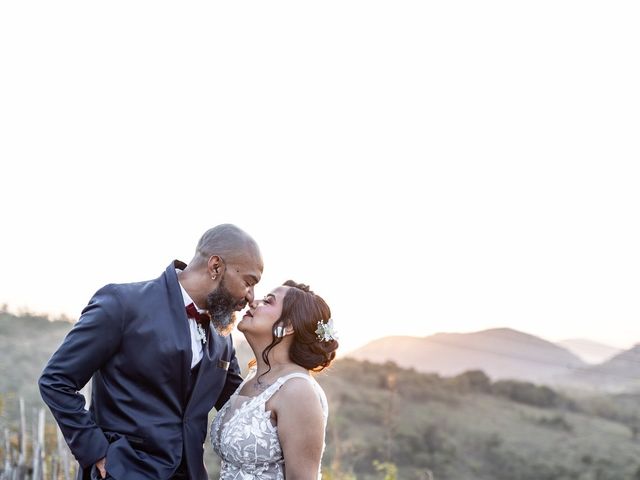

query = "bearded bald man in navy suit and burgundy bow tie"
[{"left": 39, "top": 224, "right": 263, "bottom": 480}]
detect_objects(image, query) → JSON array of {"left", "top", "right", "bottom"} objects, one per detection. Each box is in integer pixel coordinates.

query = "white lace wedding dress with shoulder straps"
[{"left": 211, "top": 369, "right": 328, "bottom": 480}]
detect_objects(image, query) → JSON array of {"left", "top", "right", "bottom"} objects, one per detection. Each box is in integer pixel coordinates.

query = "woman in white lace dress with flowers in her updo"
[{"left": 211, "top": 280, "right": 338, "bottom": 480}]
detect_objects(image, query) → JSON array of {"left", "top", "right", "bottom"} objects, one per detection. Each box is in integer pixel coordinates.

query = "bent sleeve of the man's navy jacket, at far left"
[{"left": 38, "top": 286, "right": 124, "bottom": 468}]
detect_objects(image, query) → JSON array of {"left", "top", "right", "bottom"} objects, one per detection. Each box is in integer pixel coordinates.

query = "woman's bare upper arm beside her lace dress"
[{"left": 274, "top": 378, "right": 325, "bottom": 480}]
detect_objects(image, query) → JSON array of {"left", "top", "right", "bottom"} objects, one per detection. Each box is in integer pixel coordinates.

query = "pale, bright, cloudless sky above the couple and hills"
[{"left": 0, "top": 0, "right": 640, "bottom": 352}]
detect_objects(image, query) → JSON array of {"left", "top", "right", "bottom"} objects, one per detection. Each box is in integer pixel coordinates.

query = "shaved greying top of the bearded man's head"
[{"left": 191, "top": 223, "right": 262, "bottom": 268}]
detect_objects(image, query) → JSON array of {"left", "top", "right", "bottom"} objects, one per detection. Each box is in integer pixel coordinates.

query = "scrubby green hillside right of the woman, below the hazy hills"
[{"left": 318, "top": 359, "right": 640, "bottom": 480}]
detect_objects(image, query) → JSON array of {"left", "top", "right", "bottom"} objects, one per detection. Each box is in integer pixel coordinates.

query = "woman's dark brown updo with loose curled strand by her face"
[{"left": 262, "top": 280, "right": 338, "bottom": 372}]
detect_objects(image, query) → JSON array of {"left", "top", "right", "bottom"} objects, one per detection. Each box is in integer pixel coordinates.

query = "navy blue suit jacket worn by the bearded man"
[{"left": 39, "top": 261, "right": 242, "bottom": 480}]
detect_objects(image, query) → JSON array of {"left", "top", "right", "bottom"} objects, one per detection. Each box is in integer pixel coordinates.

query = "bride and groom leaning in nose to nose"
[{"left": 39, "top": 224, "right": 338, "bottom": 480}]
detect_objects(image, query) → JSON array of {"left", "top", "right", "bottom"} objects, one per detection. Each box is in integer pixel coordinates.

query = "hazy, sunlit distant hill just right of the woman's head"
[{"left": 349, "top": 328, "right": 586, "bottom": 382}]
